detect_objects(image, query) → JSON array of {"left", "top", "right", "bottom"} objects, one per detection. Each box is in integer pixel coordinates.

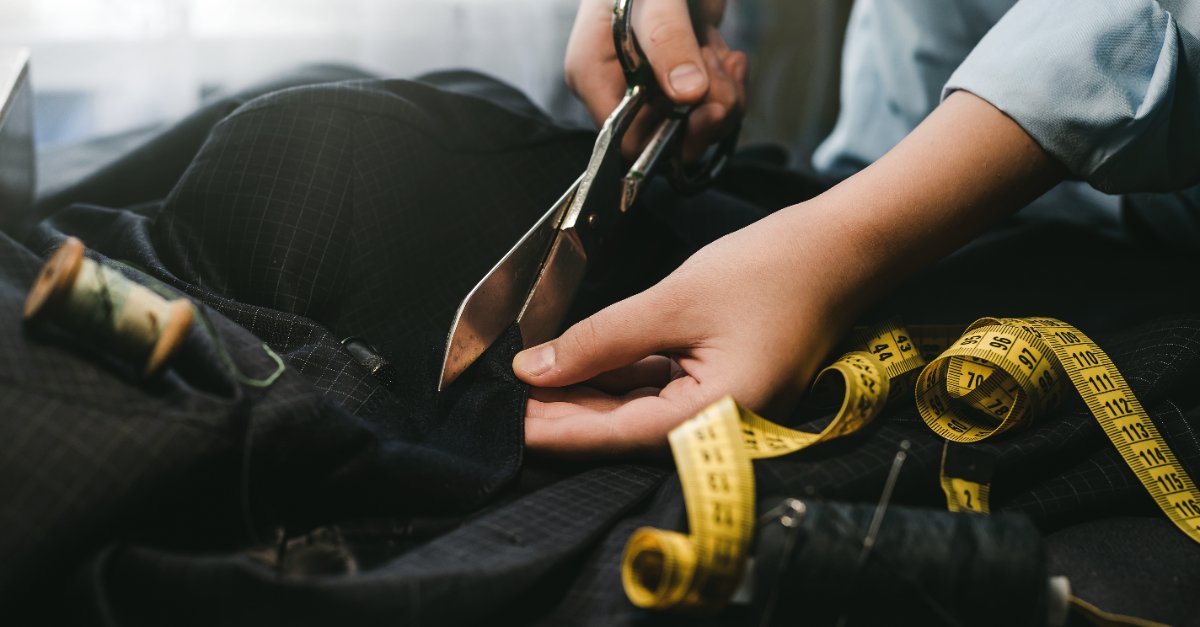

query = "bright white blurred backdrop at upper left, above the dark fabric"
[{"left": 0, "top": 0, "right": 576, "bottom": 144}]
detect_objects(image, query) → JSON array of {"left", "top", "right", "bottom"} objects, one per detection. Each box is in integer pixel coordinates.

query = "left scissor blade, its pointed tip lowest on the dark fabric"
[{"left": 438, "top": 181, "right": 578, "bottom": 390}]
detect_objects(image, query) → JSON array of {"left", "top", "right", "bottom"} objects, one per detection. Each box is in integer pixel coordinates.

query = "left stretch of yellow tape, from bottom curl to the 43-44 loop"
[{"left": 622, "top": 327, "right": 923, "bottom": 610}]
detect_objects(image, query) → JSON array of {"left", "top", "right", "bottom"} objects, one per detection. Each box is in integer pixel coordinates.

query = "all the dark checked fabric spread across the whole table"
[{"left": 7, "top": 73, "right": 1200, "bottom": 626}]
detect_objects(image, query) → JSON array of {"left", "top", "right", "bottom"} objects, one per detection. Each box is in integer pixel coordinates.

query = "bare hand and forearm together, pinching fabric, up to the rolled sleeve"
[{"left": 512, "top": 91, "right": 1064, "bottom": 455}]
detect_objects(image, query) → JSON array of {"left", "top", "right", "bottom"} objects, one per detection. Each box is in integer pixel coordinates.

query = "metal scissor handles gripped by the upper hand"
[{"left": 612, "top": 0, "right": 740, "bottom": 193}]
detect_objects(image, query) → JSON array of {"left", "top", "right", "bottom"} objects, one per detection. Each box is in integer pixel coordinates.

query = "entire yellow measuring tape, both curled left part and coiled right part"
[{"left": 622, "top": 318, "right": 1200, "bottom": 620}]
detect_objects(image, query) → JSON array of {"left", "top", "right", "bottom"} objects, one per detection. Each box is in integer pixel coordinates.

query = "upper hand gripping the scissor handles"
[{"left": 565, "top": 0, "right": 746, "bottom": 161}]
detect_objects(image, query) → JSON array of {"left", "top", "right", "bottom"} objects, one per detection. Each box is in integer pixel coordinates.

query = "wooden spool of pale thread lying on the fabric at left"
[{"left": 24, "top": 238, "right": 192, "bottom": 376}]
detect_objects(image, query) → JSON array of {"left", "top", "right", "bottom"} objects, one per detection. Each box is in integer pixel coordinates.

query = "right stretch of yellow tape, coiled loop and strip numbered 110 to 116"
[{"left": 916, "top": 318, "right": 1200, "bottom": 542}]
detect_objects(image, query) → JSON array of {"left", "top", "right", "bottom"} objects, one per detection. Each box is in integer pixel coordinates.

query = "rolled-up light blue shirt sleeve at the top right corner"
[{"left": 942, "top": 0, "right": 1200, "bottom": 193}]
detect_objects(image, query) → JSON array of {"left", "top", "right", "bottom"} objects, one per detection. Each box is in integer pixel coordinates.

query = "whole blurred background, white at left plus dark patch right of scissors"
[{"left": 0, "top": 0, "right": 851, "bottom": 165}]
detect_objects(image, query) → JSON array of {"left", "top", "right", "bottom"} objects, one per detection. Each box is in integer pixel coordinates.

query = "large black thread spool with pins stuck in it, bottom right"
[{"left": 751, "top": 500, "right": 1063, "bottom": 626}]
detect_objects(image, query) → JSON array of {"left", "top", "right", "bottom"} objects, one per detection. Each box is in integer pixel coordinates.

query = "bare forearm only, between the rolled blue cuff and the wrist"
[{"left": 778, "top": 91, "right": 1064, "bottom": 314}]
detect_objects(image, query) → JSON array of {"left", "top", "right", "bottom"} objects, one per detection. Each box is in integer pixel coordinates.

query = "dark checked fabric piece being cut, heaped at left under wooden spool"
[{"left": 0, "top": 75, "right": 600, "bottom": 605}]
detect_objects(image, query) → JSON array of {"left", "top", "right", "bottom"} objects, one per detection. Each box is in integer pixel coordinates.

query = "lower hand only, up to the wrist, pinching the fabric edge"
[{"left": 514, "top": 200, "right": 853, "bottom": 454}]
